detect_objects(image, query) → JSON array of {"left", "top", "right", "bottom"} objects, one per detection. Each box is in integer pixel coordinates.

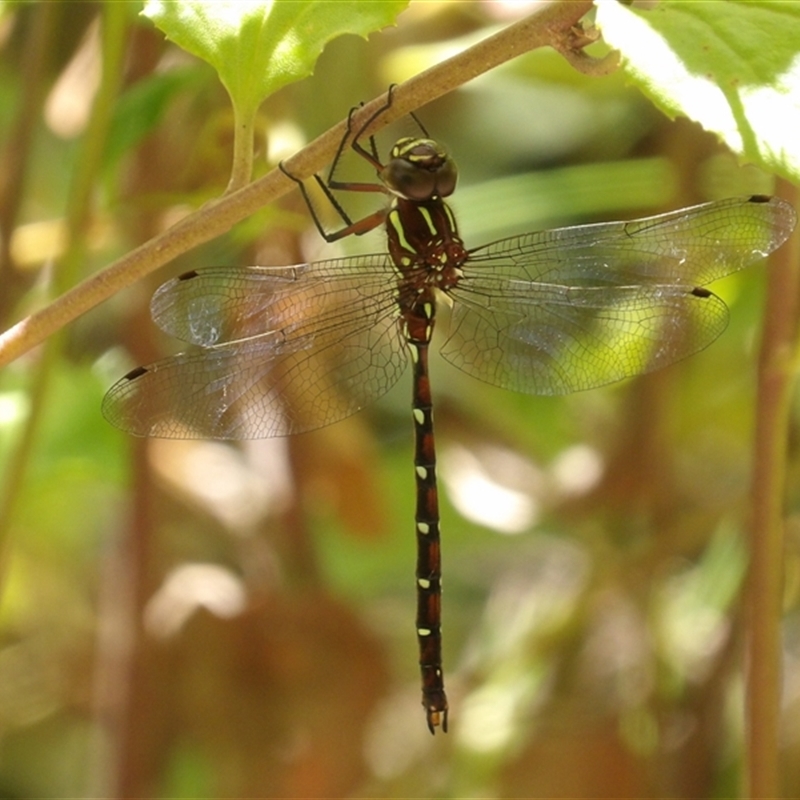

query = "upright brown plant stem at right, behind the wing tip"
[{"left": 745, "top": 181, "right": 800, "bottom": 798}]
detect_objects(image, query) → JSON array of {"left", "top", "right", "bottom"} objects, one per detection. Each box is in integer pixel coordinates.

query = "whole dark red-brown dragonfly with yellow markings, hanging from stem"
[{"left": 102, "top": 97, "right": 797, "bottom": 733}]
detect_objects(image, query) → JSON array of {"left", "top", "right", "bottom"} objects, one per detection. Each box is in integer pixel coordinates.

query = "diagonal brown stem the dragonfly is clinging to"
[{"left": 0, "top": 0, "right": 592, "bottom": 366}]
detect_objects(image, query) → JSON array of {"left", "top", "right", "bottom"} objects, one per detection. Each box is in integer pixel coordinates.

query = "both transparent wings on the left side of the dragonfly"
[{"left": 103, "top": 255, "right": 406, "bottom": 439}]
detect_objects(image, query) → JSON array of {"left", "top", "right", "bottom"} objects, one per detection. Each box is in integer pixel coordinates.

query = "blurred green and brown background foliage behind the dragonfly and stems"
[{"left": 0, "top": 1, "right": 800, "bottom": 798}]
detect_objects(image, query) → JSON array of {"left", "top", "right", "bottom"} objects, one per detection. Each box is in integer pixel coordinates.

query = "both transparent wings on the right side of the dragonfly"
[{"left": 442, "top": 197, "right": 796, "bottom": 394}]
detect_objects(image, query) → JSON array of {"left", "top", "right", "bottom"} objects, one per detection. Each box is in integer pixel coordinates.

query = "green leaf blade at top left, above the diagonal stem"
[{"left": 142, "top": 0, "right": 408, "bottom": 115}]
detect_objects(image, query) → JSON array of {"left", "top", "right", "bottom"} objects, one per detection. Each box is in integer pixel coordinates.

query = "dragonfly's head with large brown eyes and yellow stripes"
[{"left": 379, "top": 137, "right": 458, "bottom": 202}]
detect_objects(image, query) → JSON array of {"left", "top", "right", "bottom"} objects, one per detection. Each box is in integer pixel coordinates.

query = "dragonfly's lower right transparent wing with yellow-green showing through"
[{"left": 442, "top": 283, "right": 728, "bottom": 394}]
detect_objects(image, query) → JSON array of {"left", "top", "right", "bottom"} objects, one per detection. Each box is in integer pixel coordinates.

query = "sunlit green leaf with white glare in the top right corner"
[{"left": 597, "top": 0, "right": 800, "bottom": 181}]
